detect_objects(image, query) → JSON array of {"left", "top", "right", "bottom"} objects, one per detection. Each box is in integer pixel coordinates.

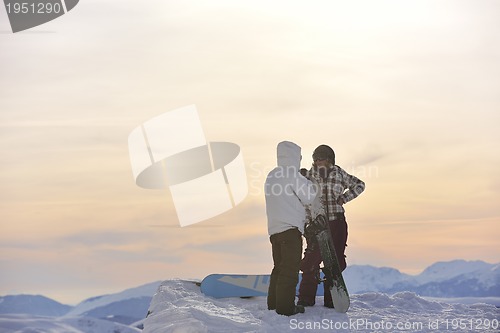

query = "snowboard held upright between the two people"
[{"left": 306, "top": 214, "right": 351, "bottom": 313}]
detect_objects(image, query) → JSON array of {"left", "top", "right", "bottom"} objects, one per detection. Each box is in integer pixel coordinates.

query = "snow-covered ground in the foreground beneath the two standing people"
[{"left": 143, "top": 280, "right": 500, "bottom": 333}]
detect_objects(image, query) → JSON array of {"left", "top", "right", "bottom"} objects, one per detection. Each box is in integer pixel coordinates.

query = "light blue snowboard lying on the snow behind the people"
[{"left": 200, "top": 274, "right": 323, "bottom": 298}]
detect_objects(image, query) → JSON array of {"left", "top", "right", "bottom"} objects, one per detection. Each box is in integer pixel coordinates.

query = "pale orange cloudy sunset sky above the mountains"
[{"left": 0, "top": 0, "right": 500, "bottom": 304}]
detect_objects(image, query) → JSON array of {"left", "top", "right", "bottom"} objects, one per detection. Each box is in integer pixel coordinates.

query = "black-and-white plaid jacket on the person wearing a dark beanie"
[{"left": 306, "top": 165, "right": 365, "bottom": 220}]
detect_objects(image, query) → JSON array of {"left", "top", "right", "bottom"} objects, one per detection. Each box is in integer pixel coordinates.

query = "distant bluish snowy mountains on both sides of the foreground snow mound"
[{"left": 0, "top": 260, "right": 500, "bottom": 327}]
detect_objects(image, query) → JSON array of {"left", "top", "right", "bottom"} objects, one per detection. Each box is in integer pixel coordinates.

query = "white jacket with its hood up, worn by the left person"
[{"left": 264, "top": 141, "right": 318, "bottom": 235}]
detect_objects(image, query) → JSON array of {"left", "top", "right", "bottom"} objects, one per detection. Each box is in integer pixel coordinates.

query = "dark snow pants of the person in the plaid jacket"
[{"left": 299, "top": 213, "right": 347, "bottom": 304}]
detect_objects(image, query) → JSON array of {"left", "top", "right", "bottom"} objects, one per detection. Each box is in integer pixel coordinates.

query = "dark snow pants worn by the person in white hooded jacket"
[{"left": 267, "top": 228, "right": 302, "bottom": 316}]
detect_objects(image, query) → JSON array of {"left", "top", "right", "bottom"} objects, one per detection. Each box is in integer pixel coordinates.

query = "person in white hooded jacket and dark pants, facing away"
[{"left": 265, "top": 141, "right": 318, "bottom": 316}]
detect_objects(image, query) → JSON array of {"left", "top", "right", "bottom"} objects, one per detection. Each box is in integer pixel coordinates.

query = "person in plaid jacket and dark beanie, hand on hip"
[{"left": 297, "top": 145, "right": 365, "bottom": 308}]
